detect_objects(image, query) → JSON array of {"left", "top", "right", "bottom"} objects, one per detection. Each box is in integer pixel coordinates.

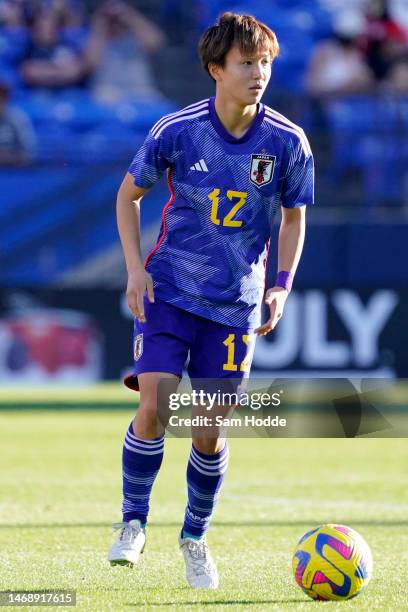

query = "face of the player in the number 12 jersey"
[{"left": 216, "top": 47, "right": 272, "bottom": 105}]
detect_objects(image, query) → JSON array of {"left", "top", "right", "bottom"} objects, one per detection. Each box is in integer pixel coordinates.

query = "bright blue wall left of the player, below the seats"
[{"left": 0, "top": 160, "right": 168, "bottom": 286}]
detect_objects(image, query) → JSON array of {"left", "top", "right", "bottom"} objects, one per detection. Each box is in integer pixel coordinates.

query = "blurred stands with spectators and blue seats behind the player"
[{"left": 0, "top": 0, "right": 408, "bottom": 210}]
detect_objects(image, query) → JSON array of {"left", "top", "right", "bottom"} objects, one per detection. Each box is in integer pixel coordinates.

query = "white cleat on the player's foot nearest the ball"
[{"left": 179, "top": 536, "right": 219, "bottom": 589}]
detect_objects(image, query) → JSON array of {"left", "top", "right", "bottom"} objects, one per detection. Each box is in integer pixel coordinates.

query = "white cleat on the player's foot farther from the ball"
[{"left": 108, "top": 519, "right": 146, "bottom": 567}]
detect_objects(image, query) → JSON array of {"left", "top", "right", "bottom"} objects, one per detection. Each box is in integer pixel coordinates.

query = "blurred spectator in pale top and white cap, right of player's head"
[{"left": 306, "top": 12, "right": 374, "bottom": 96}]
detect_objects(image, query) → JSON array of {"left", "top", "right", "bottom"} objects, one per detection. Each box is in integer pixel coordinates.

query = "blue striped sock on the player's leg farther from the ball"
[{"left": 122, "top": 423, "right": 164, "bottom": 527}]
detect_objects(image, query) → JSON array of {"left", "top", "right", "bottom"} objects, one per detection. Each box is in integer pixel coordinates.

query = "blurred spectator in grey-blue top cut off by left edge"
[{"left": 0, "top": 80, "right": 34, "bottom": 166}]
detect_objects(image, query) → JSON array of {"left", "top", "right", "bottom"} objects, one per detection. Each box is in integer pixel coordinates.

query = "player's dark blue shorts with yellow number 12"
[{"left": 124, "top": 299, "right": 256, "bottom": 391}]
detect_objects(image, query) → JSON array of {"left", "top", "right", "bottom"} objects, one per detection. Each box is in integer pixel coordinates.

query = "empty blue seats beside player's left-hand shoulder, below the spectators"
[{"left": 10, "top": 89, "right": 175, "bottom": 164}]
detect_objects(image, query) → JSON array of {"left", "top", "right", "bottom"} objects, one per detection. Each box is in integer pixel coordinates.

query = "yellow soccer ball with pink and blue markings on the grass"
[{"left": 292, "top": 524, "right": 373, "bottom": 601}]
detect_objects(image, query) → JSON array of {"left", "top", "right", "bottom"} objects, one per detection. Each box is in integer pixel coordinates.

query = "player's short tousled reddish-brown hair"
[{"left": 198, "top": 13, "right": 279, "bottom": 74}]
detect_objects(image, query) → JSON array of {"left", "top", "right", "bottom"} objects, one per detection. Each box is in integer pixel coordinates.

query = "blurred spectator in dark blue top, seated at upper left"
[{"left": 20, "top": 12, "right": 86, "bottom": 89}]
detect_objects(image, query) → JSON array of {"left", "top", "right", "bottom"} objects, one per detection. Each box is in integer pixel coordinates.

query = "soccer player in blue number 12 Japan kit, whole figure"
[{"left": 108, "top": 13, "right": 313, "bottom": 588}]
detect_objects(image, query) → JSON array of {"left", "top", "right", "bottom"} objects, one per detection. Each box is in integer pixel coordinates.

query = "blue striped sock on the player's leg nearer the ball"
[{"left": 182, "top": 444, "right": 228, "bottom": 539}]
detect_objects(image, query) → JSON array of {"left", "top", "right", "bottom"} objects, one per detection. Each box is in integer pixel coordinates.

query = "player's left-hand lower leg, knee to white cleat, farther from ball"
[{"left": 108, "top": 372, "right": 178, "bottom": 566}]
